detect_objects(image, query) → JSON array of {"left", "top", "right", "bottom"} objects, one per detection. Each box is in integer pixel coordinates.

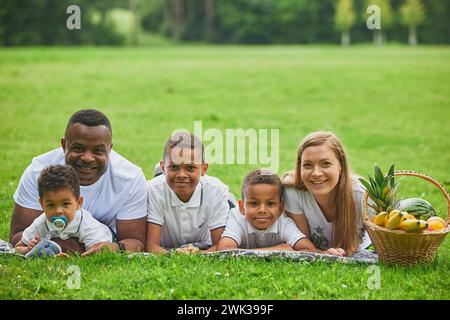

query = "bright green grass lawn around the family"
[{"left": 0, "top": 46, "right": 450, "bottom": 299}]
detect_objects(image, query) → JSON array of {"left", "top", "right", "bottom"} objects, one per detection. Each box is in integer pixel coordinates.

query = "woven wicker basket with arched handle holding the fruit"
[{"left": 363, "top": 170, "right": 450, "bottom": 266}]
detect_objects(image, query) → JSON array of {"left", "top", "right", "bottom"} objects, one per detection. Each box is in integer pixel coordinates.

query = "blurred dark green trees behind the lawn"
[{"left": 0, "top": 0, "right": 450, "bottom": 46}]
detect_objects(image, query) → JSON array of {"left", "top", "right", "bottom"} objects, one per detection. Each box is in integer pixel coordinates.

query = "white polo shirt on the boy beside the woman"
[{"left": 222, "top": 208, "right": 305, "bottom": 249}]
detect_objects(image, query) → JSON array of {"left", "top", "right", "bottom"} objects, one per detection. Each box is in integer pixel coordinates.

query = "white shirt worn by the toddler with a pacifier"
[{"left": 22, "top": 209, "right": 113, "bottom": 249}]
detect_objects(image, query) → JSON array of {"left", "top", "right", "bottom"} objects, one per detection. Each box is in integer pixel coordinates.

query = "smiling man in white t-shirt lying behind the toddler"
[{"left": 10, "top": 109, "right": 147, "bottom": 255}]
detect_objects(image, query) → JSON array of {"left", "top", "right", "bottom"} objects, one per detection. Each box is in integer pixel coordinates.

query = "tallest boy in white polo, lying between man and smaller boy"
[{"left": 146, "top": 132, "right": 230, "bottom": 253}]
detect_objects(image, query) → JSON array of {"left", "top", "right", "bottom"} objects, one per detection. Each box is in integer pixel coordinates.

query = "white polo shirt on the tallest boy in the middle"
[{"left": 147, "top": 174, "right": 229, "bottom": 248}]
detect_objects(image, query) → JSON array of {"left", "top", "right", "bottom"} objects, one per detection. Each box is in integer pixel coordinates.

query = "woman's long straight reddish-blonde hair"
[{"left": 283, "top": 131, "right": 360, "bottom": 255}]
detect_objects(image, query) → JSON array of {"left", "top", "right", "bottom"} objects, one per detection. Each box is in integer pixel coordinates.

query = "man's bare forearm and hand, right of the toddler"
[{"left": 82, "top": 217, "right": 147, "bottom": 257}]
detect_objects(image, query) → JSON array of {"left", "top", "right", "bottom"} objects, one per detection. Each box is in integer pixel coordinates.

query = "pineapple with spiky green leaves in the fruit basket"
[{"left": 359, "top": 165, "right": 400, "bottom": 214}]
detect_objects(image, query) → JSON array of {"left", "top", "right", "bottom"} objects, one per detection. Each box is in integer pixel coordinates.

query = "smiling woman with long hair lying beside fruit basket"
[{"left": 283, "top": 131, "right": 370, "bottom": 256}]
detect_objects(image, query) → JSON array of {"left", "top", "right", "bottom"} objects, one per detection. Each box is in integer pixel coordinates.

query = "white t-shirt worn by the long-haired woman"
[{"left": 284, "top": 177, "right": 371, "bottom": 250}]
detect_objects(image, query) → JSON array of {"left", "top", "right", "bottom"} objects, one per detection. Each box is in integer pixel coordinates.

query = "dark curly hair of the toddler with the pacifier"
[{"left": 38, "top": 165, "right": 80, "bottom": 199}]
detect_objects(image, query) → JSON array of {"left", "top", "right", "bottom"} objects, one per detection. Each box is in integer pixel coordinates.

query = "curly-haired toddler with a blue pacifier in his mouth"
[{"left": 15, "top": 165, "right": 113, "bottom": 255}]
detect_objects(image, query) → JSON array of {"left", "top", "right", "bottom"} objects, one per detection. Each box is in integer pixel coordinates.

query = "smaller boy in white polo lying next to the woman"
[{"left": 218, "top": 169, "right": 344, "bottom": 254}]
